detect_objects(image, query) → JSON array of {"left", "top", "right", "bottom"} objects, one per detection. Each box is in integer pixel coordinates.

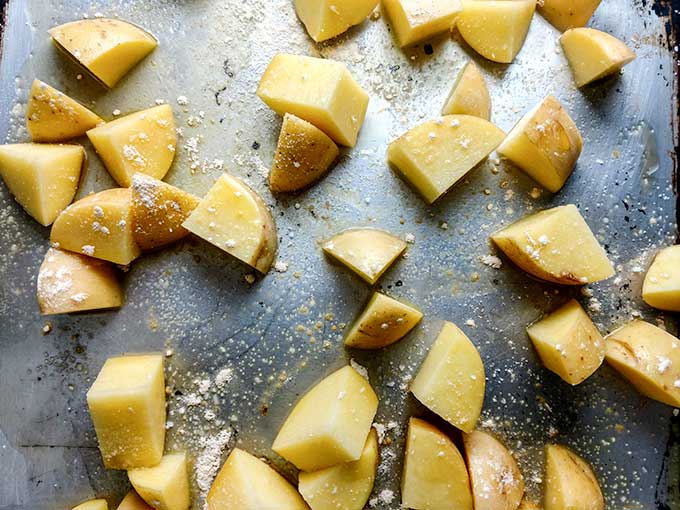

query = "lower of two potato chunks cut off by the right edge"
[{"left": 606, "top": 320, "right": 680, "bottom": 407}]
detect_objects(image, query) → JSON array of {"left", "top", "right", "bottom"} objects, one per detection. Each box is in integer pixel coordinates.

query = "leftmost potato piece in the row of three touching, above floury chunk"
[{"left": 50, "top": 188, "right": 141, "bottom": 265}]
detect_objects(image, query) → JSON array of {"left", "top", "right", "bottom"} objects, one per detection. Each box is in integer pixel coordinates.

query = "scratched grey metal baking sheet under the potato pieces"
[{"left": 0, "top": 0, "right": 680, "bottom": 510}]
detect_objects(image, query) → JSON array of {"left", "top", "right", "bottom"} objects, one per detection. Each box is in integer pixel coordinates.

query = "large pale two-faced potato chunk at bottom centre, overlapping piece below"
[{"left": 272, "top": 366, "right": 378, "bottom": 471}]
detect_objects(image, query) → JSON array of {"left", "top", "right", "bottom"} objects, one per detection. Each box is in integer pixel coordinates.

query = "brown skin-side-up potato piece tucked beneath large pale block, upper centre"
[{"left": 269, "top": 114, "right": 340, "bottom": 193}]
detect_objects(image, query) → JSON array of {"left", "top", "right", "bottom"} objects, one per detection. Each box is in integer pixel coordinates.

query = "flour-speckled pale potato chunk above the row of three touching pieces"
[{"left": 87, "top": 104, "right": 177, "bottom": 188}]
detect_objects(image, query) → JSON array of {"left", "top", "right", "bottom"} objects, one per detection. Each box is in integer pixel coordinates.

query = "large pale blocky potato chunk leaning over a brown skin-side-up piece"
[{"left": 257, "top": 54, "right": 368, "bottom": 147}]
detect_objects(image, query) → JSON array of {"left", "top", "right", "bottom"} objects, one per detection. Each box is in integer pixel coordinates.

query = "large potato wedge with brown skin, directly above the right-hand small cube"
[{"left": 491, "top": 204, "right": 614, "bottom": 285}]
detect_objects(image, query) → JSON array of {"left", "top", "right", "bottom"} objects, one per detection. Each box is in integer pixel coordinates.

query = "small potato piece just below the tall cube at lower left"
[{"left": 128, "top": 453, "right": 191, "bottom": 510}]
